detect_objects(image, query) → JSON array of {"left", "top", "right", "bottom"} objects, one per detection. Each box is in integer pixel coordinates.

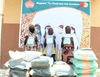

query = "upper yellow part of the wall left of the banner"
[{"left": 4, "top": 0, "right": 21, "bottom": 24}]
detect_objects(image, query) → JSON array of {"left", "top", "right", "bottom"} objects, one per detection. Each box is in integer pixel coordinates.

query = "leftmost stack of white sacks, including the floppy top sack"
[{"left": 5, "top": 51, "right": 42, "bottom": 77}]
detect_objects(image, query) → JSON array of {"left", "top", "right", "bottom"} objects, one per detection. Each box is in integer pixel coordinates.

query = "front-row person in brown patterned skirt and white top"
[{"left": 61, "top": 26, "right": 74, "bottom": 64}]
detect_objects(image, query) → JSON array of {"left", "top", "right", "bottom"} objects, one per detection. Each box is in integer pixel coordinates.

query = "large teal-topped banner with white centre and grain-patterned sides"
[{"left": 19, "top": 0, "right": 90, "bottom": 48}]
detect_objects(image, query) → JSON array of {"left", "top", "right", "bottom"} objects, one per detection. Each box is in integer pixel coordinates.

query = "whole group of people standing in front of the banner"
[{"left": 24, "top": 24, "right": 79, "bottom": 64}]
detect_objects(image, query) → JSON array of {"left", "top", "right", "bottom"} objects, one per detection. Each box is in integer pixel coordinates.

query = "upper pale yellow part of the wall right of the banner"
[{"left": 91, "top": 0, "right": 100, "bottom": 27}]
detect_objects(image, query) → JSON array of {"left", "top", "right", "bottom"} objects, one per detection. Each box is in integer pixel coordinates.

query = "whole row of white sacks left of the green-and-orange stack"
[{"left": 5, "top": 51, "right": 76, "bottom": 77}]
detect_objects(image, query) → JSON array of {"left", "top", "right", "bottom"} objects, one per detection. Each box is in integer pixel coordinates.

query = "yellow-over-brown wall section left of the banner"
[{"left": 0, "top": 0, "right": 23, "bottom": 67}]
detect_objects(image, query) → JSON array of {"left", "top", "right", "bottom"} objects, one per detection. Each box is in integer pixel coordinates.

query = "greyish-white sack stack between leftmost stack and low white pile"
[{"left": 30, "top": 56, "right": 55, "bottom": 77}]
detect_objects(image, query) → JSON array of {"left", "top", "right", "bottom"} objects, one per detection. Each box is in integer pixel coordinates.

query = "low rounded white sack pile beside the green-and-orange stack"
[{"left": 52, "top": 61, "right": 77, "bottom": 77}]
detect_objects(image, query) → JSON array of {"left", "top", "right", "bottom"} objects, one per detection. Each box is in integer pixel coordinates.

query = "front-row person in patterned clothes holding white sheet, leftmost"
[{"left": 24, "top": 24, "right": 39, "bottom": 51}]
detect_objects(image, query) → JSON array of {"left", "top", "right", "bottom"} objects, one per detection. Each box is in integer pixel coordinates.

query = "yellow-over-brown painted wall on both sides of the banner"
[{"left": 2, "top": 0, "right": 100, "bottom": 66}]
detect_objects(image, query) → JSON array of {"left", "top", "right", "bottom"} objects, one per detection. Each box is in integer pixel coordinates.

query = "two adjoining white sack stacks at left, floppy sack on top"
[{"left": 5, "top": 51, "right": 53, "bottom": 77}]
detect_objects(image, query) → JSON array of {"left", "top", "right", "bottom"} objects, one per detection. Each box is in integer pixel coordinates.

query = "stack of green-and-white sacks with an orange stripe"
[{"left": 70, "top": 48, "right": 98, "bottom": 77}]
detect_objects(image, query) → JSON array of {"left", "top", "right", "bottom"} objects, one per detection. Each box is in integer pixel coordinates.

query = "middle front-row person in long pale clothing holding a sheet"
[{"left": 44, "top": 28, "right": 56, "bottom": 61}]
